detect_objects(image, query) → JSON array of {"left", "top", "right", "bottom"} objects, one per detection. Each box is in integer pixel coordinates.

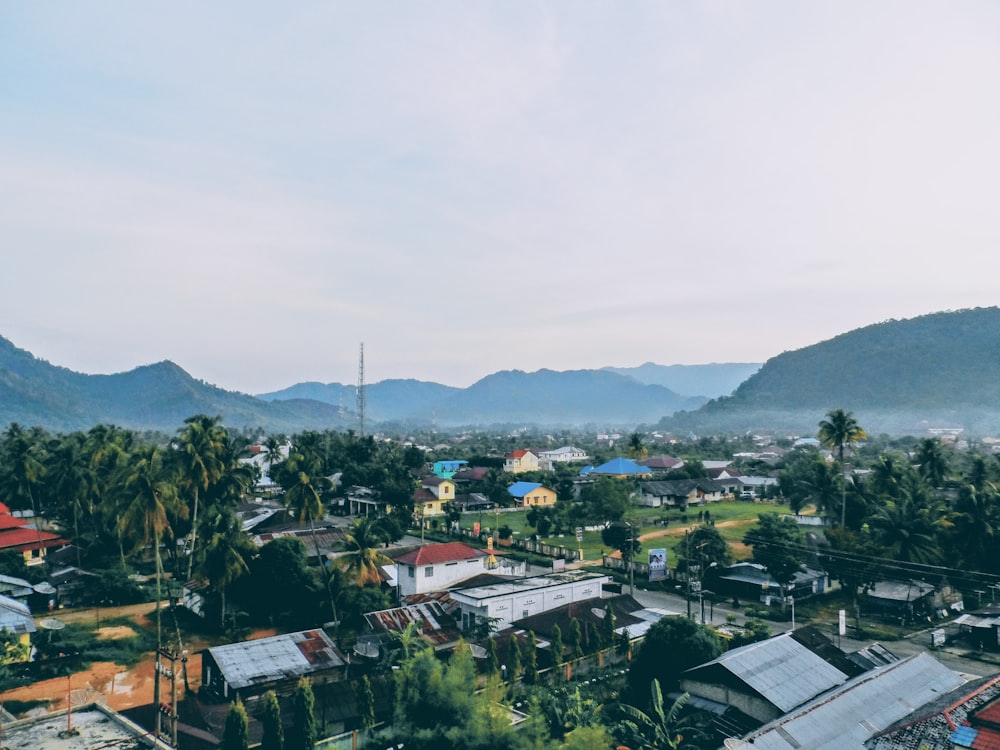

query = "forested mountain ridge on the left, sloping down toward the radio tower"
[{"left": 0, "top": 337, "right": 344, "bottom": 433}]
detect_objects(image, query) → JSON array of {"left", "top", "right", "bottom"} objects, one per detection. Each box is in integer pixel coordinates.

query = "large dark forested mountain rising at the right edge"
[{"left": 659, "top": 307, "right": 1000, "bottom": 435}]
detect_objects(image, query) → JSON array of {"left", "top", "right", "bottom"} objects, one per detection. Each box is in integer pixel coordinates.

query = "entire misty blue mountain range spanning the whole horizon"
[{"left": 0, "top": 307, "right": 1000, "bottom": 435}]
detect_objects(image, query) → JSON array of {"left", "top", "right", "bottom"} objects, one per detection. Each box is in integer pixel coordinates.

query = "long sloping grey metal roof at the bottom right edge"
[{"left": 744, "top": 654, "right": 963, "bottom": 750}]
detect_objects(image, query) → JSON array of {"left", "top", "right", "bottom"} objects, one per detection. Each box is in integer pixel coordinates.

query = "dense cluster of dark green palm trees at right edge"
[{"left": 779, "top": 409, "right": 1000, "bottom": 585}]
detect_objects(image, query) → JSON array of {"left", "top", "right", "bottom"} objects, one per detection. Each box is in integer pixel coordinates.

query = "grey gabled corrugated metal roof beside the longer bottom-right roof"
[{"left": 685, "top": 633, "right": 848, "bottom": 712}]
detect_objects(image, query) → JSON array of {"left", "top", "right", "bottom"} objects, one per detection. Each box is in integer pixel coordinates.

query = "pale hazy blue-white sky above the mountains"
[{"left": 0, "top": 0, "right": 1000, "bottom": 393}]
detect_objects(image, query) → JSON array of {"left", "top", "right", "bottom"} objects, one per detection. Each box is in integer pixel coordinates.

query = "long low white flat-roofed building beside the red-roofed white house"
[{"left": 451, "top": 570, "right": 611, "bottom": 631}]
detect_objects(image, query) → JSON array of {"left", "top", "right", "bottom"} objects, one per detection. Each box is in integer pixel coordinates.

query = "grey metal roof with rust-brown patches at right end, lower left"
[{"left": 208, "top": 630, "right": 344, "bottom": 690}]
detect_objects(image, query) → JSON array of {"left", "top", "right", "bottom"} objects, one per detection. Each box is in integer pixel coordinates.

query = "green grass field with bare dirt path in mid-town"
[{"left": 460, "top": 502, "right": 788, "bottom": 567}]
